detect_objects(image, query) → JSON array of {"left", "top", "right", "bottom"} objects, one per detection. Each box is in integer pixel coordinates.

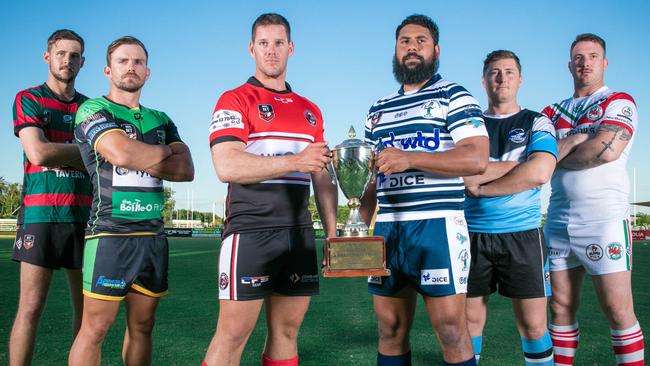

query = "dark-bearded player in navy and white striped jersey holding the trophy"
[{"left": 362, "top": 15, "right": 488, "bottom": 366}]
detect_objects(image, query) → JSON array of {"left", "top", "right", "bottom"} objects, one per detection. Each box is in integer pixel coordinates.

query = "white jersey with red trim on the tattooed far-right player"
[{"left": 542, "top": 86, "right": 638, "bottom": 225}]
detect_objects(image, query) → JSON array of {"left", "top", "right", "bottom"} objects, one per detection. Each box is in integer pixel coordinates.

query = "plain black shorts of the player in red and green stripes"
[{"left": 11, "top": 222, "right": 87, "bottom": 269}]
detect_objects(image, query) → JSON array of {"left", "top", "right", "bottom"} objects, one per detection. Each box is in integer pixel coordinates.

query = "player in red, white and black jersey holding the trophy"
[{"left": 203, "top": 14, "right": 337, "bottom": 366}]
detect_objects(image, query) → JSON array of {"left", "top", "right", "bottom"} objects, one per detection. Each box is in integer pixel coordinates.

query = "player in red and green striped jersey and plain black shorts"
[{"left": 9, "top": 29, "right": 92, "bottom": 365}]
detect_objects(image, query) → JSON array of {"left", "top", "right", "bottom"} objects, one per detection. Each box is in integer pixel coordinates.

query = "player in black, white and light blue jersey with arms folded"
[{"left": 464, "top": 50, "right": 557, "bottom": 365}]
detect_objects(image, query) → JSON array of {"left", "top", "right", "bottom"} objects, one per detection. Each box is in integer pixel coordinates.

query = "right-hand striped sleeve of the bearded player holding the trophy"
[{"left": 447, "top": 85, "right": 488, "bottom": 142}]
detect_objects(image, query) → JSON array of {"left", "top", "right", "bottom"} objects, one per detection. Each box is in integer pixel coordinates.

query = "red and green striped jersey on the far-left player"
[{"left": 13, "top": 84, "right": 92, "bottom": 224}]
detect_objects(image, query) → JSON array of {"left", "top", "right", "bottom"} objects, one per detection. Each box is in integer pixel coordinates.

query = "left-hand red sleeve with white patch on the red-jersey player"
[{"left": 209, "top": 92, "right": 250, "bottom": 147}]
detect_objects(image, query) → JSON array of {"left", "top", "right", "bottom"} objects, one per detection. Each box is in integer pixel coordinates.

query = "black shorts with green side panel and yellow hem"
[{"left": 83, "top": 235, "right": 169, "bottom": 301}]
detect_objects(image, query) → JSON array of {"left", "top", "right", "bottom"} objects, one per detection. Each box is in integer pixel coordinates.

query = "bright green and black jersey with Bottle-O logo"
[{"left": 75, "top": 97, "right": 182, "bottom": 238}]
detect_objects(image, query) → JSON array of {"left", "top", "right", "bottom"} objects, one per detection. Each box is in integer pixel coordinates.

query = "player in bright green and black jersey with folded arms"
[{"left": 69, "top": 36, "right": 194, "bottom": 365}]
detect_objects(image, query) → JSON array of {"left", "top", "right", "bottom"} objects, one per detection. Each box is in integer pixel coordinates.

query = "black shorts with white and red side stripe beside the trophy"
[{"left": 219, "top": 227, "right": 319, "bottom": 300}]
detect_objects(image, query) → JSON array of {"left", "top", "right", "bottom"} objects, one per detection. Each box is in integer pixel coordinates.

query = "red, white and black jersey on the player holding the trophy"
[{"left": 210, "top": 77, "right": 323, "bottom": 237}]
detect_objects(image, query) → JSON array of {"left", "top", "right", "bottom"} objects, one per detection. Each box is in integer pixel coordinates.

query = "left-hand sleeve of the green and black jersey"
[{"left": 74, "top": 103, "right": 123, "bottom": 150}]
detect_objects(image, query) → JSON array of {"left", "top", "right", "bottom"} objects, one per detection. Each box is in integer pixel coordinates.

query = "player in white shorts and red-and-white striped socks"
[{"left": 542, "top": 33, "right": 644, "bottom": 365}]
